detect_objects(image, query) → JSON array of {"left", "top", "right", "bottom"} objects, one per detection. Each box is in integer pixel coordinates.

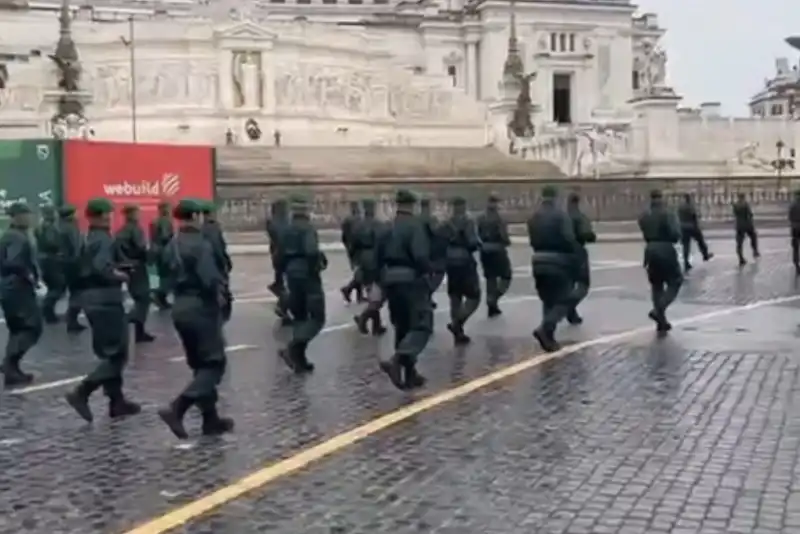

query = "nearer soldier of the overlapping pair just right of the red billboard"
[{"left": 278, "top": 197, "right": 328, "bottom": 374}]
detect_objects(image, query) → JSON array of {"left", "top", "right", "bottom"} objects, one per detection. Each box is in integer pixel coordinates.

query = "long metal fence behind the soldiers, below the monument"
[{"left": 217, "top": 177, "right": 792, "bottom": 232}]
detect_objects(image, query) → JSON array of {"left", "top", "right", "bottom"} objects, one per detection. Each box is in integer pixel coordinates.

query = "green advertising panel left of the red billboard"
[{"left": 0, "top": 139, "right": 61, "bottom": 227}]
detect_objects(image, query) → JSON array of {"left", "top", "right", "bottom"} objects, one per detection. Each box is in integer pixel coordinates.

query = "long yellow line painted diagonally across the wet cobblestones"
[{"left": 124, "top": 295, "right": 800, "bottom": 534}]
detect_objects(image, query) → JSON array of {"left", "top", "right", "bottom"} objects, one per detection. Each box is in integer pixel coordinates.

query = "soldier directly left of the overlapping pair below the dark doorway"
[{"left": 477, "top": 194, "right": 512, "bottom": 317}]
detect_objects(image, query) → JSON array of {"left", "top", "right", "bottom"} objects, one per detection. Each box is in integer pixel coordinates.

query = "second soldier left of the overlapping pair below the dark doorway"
[{"left": 442, "top": 197, "right": 481, "bottom": 345}]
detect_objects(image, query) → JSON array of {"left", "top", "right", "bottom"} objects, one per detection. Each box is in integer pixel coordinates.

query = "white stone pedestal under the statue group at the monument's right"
[{"left": 630, "top": 89, "right": 683, "bottom": 162}]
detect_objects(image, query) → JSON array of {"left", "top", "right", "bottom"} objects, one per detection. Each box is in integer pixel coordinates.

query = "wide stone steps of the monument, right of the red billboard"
[{"left": 217, "top": 146, "right": 564, "bottom": 183}]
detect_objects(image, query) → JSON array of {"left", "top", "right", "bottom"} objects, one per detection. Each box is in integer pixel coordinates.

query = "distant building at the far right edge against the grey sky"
[{"left": 749, "top": 37, "right": 800, "bottom": 118}]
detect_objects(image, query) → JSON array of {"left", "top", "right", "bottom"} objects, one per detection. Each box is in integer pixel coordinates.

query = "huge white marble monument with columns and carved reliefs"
[{"left": 0, "top": 0, "right": 800, "bottom": 180}]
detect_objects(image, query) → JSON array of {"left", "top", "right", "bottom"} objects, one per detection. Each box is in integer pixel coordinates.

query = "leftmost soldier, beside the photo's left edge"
[{"left": 0, "top": 202, "right": 42, "bottom": 387}]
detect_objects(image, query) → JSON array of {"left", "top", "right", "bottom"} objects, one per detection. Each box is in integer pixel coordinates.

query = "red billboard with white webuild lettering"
[{"left": 64, "top": 141, "right": 214, "bottom": 231}]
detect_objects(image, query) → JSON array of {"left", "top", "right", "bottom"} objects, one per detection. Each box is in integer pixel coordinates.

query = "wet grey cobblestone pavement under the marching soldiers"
[{"left": 0, "top": 239, "right": 800, "bottom": 534}]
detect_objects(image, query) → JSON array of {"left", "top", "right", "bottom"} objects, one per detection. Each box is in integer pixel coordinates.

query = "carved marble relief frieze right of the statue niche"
[{"left": 275, "top": 63, "right": 453, "bottom": 120}]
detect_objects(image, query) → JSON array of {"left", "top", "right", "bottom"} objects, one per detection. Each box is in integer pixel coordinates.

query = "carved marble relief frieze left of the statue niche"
[{"left": 88, "top": 61, "right": 217, "bottom": 109}]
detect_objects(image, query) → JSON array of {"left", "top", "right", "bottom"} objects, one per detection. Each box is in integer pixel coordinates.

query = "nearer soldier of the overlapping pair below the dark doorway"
[{"left": 528, "top": 186, "right": 580, "bottom": 352}]
